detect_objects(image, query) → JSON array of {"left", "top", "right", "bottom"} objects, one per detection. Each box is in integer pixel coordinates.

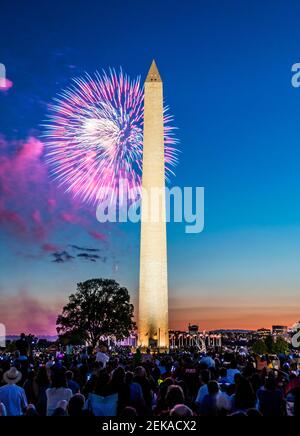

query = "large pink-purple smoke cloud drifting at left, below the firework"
[{"left": 0, "top": 135, "right": 106, "bottom": 244}]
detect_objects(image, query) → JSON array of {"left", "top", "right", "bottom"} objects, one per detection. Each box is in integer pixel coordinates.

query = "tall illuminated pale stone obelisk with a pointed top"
[{"left": 138, "top": 60, "right": 169, "bottom": 348}]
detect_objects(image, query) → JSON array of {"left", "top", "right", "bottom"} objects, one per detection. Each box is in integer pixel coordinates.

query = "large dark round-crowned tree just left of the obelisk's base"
[{"left": 56, "top": 279, "right": 135, "bottom": 347}]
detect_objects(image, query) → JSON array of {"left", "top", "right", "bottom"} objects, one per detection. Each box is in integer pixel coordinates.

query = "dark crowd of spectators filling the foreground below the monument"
[{"left": 0, "top": 335, "right": 300, "bottom": 419}]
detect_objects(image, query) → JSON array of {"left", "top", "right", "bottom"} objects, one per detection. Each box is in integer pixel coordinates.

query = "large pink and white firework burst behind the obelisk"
[{"left": 44, "top": 70, "right": 177, "bottom": 203}]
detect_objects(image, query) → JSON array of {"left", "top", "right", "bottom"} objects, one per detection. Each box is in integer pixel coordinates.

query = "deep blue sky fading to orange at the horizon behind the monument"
[{"left": 0, "top": 0, "right": 300, "bottom": 331}]
